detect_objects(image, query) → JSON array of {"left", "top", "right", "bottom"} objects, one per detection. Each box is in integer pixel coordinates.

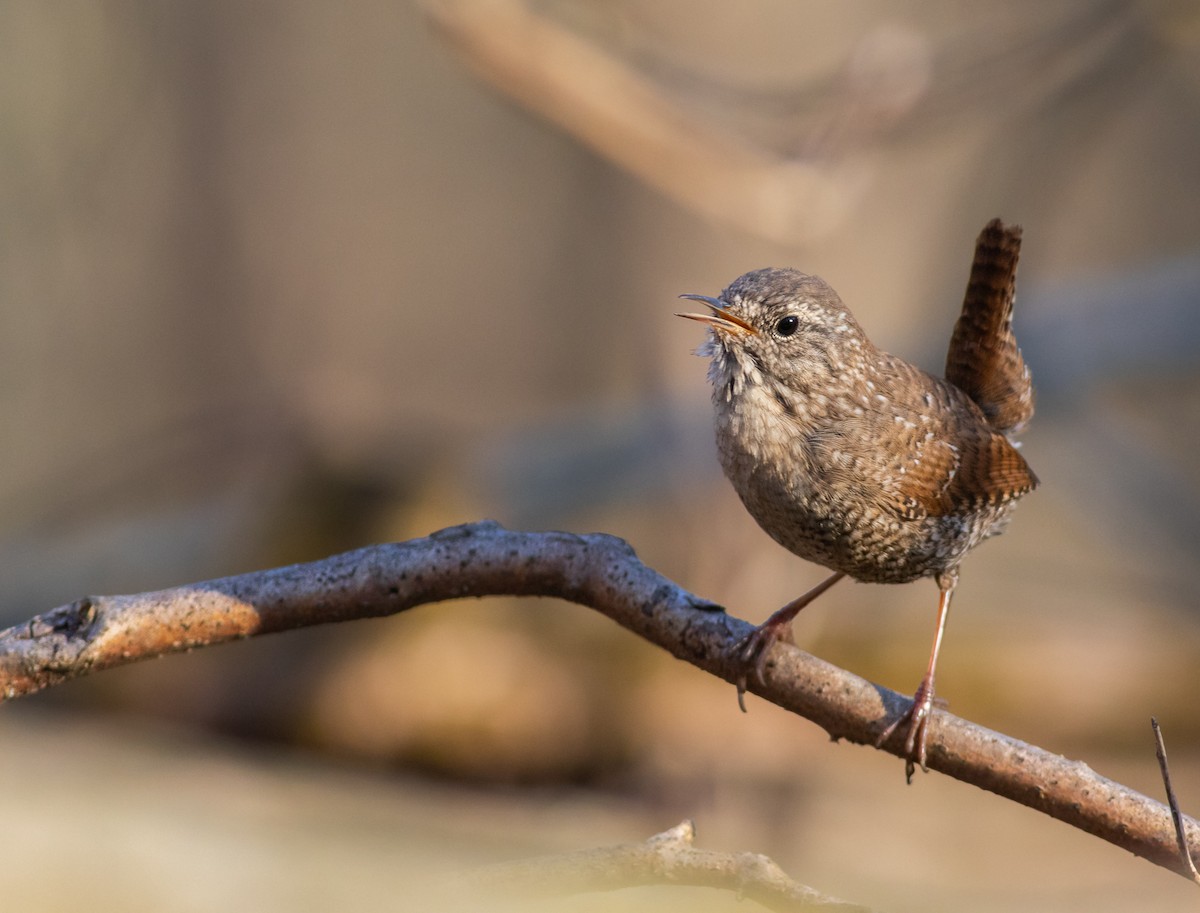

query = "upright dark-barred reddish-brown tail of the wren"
[{"left": 946, "top": 218, "right": 1033, "bottom": 436}]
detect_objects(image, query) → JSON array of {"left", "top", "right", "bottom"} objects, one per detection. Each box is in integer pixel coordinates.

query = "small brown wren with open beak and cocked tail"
[{"left": 679, "top": 220, "right": 1038, "bottom": 780}]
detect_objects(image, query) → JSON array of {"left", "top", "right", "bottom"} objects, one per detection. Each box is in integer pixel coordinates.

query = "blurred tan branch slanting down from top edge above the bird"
[{"left": 422, "top": 0, "right": 907, "bottom": 242}]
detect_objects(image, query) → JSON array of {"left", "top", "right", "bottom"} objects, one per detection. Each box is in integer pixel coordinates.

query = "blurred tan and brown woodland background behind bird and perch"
[{"left": 0, "top": 0, "right": 1200, "bottom": 911}]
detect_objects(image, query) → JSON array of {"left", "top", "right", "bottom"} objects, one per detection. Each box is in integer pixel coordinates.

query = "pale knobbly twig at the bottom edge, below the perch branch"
[{"left": 462, "top": 821, "right": 866, "bottom": 913}]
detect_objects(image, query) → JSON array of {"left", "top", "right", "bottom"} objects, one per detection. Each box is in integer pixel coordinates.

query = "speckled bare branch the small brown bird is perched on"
[{"left": 0, "top": 522, "right": 1200, "bottom": 876}]
